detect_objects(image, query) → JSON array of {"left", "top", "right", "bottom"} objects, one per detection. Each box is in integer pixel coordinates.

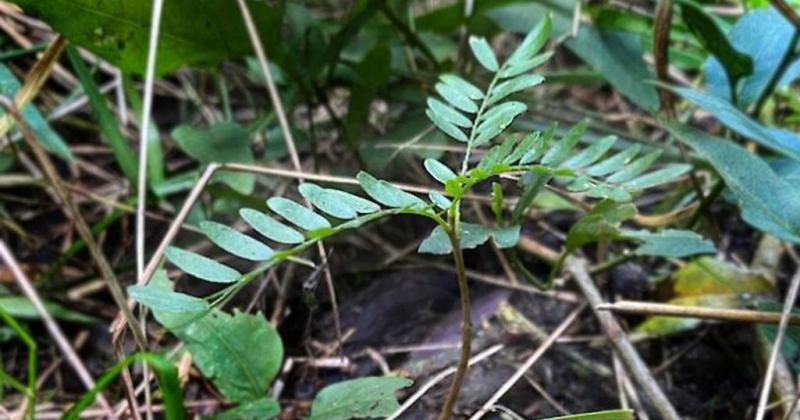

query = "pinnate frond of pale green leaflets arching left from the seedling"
[{"left": 160, "top": 172, "right": 444, "bottom": 285}]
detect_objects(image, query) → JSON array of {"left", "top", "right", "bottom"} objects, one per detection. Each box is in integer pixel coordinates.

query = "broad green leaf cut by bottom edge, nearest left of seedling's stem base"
[{"left": 309, "top": 376, "right": 412, "bottom": 420}]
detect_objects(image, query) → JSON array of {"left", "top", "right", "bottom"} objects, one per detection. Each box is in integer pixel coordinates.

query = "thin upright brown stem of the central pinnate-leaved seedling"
[{"left": 438, "top": 199, "right": 472, "bottom": 420}]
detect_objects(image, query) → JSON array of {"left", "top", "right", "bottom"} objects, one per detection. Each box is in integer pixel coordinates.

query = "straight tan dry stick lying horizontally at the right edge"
[{"left": 595, "top": 300, "right": 800, "bottom": 325}]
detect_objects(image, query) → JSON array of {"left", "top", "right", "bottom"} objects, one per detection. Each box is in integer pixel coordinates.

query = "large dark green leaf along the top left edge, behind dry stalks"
[{"left": 15, "top": 0, "right": 283, "bottom": 74}]
